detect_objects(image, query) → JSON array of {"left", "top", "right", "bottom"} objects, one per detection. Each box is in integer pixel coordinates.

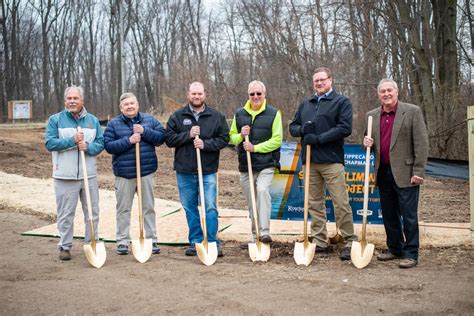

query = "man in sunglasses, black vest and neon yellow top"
[{"left": 230, "top": 81, "right": 283, "bottom": 243}]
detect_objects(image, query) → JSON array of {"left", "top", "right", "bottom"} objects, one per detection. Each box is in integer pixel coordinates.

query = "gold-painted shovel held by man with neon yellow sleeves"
[{"left": 245, "top": 135, "right": 270, "bottom": 261}]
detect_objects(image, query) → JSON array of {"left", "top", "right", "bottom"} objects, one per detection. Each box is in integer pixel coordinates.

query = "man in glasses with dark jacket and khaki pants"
[{"left": 290, "top": 67, "right": 357, "bottom": 260}]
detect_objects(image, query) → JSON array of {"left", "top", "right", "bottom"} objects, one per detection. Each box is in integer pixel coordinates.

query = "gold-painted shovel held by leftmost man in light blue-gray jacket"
[{"left": 77, "top": 127, "right": 107, "bottom": 268}]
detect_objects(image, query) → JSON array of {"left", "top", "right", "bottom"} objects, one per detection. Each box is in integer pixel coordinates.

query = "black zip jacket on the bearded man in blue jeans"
[{"left": 165, "top": 104, "right": 229, "bottom": 174}]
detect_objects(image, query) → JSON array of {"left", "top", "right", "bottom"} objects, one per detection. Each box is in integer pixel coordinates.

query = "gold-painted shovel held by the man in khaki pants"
[{"left": 293, "top": 145, "right": 316, "bottom": 266}]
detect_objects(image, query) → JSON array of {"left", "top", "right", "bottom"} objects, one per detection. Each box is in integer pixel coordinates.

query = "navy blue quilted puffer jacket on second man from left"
[{"left": 104, "top": 112, "right": 165, "bottom": 179}]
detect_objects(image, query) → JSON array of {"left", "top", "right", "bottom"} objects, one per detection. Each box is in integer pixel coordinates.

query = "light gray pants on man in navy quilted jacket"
[{"left": 115, "top": 173, "right": 157, "bottom": 246}]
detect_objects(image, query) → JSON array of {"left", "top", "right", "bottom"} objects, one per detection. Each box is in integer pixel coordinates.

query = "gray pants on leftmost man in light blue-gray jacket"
[{"left": 54, "top": 177, "right": 99, "bottom": 250}]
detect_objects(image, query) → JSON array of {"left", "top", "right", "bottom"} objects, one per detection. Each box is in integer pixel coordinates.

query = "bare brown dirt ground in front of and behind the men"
[{"left": 0, "top": 128, "right": 474, "bottom": 315}]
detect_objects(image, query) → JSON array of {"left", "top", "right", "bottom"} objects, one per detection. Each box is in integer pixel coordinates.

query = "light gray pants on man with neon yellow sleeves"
[{"left": 240, "top": 167, "right": 275, "bottom": 240}]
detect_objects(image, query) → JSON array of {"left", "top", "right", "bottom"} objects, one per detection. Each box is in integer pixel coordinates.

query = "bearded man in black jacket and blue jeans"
[{"left": 165, "top": 82, "right": 229, "bottom": 257}]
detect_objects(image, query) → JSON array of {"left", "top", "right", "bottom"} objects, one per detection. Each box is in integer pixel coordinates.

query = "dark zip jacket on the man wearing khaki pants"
[{"left": 289, "top": 90, "right": 352, "bottom": 164}]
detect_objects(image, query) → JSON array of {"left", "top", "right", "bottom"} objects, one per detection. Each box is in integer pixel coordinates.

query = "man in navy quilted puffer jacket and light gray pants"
[{"left": 104, "top": 93, "right": 165, "bottom": 255}]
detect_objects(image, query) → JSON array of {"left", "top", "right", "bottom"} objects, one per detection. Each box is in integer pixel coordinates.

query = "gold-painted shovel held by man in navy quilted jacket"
[{"left": 132, "top": 143, "right": 153, "bottom": 263}]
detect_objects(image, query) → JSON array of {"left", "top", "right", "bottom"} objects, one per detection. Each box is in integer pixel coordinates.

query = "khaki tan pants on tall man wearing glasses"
[{"left": 305, "top": 163, "right": 357, "bottom": 247}]
